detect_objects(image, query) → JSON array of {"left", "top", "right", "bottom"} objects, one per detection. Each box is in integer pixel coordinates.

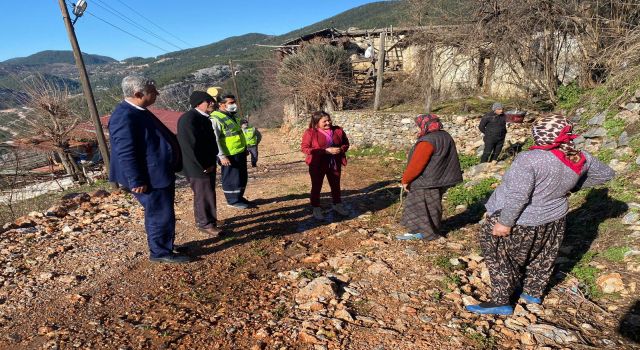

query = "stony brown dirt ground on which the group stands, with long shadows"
[{"left": 0, "top": 130, "right": 638, "bottom": 350}]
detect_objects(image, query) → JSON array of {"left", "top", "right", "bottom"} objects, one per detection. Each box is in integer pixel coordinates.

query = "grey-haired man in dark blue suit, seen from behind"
[{"left": 109, "top": 76, "right": 191, "bottom": 263}]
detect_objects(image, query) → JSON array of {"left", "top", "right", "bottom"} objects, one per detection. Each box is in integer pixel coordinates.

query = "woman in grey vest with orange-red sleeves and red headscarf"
[{"left": 396, "top": 114, "right": 462, "bottom": 241}]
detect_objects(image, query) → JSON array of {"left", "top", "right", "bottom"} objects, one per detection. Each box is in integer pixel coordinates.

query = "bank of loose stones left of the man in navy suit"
[{"left": 0, "top": 190, "right": 140, "bottom": 323}]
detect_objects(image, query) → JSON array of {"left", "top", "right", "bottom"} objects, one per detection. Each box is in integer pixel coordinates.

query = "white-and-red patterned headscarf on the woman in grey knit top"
[{"left": 530, "top": 114, "right": 586, "bottom": 175}]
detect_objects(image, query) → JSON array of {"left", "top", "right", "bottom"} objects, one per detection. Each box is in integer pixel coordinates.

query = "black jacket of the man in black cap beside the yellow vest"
[{"left": 178, "top": 109, "right": 218, "bottom": 178}]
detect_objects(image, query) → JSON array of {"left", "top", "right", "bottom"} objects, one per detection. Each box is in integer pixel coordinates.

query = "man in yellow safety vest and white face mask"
[{"left": 211, "top": 95, "right": 255, "bottom": 209}]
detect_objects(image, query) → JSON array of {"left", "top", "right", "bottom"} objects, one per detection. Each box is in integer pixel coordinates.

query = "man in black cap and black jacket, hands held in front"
[{"left": 178, "top": 91, "right": 220, "bottom": 237}]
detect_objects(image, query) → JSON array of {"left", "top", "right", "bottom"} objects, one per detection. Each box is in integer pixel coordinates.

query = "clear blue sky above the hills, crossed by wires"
[{"left": 0, "top": 0, "right": 384, "bottom": 61}]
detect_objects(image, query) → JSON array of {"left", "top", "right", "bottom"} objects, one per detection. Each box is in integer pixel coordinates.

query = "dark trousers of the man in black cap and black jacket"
[{"left": 187, "top": 175, "right": 218, "bottom": 228}]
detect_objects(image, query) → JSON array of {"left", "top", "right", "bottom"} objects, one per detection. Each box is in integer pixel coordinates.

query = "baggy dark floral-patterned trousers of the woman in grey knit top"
[{"left": 480, "top": 211, "right": 566, "bottom": 305}]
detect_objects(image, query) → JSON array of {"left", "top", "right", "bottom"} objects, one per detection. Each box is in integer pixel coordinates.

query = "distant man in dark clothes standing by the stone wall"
[{"left": 479, "top": 102, "right": 507, "bottom": 163}]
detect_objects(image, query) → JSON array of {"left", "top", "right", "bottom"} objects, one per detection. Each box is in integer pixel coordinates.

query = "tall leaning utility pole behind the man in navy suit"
[{"left": 58, "top": 0, "right": 109, "bottom": 172}]
